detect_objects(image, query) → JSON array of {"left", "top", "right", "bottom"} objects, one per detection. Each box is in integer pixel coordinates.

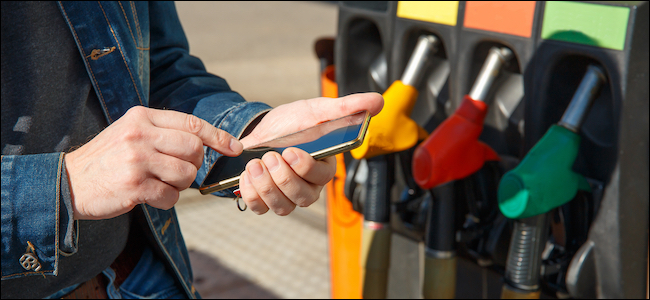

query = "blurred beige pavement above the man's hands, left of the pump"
[{"left": 176, "top": 1, "right": 338, "bottom": 106}]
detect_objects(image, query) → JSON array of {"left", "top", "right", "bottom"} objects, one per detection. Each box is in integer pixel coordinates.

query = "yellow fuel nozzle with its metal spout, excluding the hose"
[{"left": 350, "top": 35, "right": 439, "bottom": 159}]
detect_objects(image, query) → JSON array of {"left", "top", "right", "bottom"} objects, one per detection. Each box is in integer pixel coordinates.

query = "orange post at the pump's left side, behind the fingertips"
[{"left": 321, "top": 65, "right": 363, "bottom": 299}]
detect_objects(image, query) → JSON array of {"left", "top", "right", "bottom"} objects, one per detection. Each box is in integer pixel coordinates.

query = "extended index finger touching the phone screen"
[{"left": 142, "top": 109, "right": 244, "bottom": 156}]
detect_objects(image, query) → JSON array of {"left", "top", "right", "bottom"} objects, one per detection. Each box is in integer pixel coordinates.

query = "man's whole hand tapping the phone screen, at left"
[{"left": 65, "top": 106, "right": 243, "bottom": 219}]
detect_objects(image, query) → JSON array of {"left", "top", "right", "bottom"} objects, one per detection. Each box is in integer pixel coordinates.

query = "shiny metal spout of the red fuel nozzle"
[{"left": 469, "top": 47, "right": 514, "bottom": 101}]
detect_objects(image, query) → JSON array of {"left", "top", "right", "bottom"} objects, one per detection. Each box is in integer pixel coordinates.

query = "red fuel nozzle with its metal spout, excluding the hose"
[{"left": 413, "top": 47, "right": 513, "bottom": 189}]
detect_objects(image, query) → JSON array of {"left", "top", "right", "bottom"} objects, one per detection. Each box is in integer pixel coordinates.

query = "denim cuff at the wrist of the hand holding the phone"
[{"left": 194, "top": 92, "right": 271, "bottom": 197}]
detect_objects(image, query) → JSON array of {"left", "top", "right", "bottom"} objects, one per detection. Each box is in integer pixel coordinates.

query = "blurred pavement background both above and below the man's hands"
[{"left": 176, "top": 1, "right": 338, "bottom": 299}]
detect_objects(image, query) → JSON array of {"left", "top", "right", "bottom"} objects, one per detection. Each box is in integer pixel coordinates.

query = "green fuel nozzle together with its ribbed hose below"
[{"left": 498, "top": 65, "right": 607, "bottom": 299}]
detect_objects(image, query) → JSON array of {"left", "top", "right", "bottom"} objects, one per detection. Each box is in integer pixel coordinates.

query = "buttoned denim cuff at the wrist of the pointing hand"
[{"left": 2, "top": 153, "right": 63, "bottom": 280}]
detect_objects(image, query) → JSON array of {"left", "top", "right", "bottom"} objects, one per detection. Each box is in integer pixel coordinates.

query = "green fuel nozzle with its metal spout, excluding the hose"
[{"left": 498, "top": 65, "right": 607, "bottom": 219}]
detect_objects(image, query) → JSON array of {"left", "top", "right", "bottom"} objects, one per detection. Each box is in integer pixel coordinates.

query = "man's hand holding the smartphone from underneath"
[{"left": 239, "top": 93, "right": 384, "bottom": 216}]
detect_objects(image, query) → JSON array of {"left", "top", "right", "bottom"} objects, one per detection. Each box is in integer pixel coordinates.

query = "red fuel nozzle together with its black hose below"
[{"left": 412, "top": 47, "right": 513, "bottom": 298}]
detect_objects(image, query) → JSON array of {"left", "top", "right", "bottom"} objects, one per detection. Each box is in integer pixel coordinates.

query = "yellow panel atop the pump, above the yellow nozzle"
[{"left": 397, "top": 1, "right": 458, "bottom": 26}]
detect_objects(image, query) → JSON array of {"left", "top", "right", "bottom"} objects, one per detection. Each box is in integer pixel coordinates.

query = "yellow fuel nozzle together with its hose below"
[{"left": 351, "top": 35, "right": 438, "bottom": 298}]
